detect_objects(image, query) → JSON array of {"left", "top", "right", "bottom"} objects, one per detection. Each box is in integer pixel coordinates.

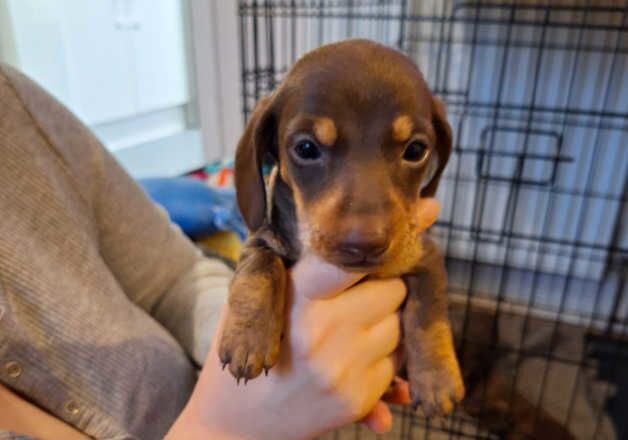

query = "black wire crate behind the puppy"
[{"left": 239, "top": 0, "right": 628, "bottom": 438}]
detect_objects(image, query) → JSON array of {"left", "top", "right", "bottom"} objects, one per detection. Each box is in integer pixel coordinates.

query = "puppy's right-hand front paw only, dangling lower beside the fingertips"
[{"left": 408, "top": 357, "right": 464, "bottom": 417}]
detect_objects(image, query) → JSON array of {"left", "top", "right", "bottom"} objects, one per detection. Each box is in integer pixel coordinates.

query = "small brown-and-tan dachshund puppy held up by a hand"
[{"left": 219, "top": 40, "right": 464, "bottom": 416}]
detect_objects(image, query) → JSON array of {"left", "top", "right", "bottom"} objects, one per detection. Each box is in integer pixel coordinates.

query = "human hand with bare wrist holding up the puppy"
[{"left": 169, "top": 200, "right": 438, "bottom": 439}]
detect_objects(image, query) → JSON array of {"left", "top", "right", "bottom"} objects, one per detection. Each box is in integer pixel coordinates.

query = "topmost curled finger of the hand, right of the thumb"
[{"left": 330, "top": 278, "right": 406, "bottom": 326}]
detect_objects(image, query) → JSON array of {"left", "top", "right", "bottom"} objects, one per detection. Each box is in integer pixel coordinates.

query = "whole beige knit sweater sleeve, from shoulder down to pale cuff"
[{"left": 0, "top": 65, "right": 232, "bottom": 365}]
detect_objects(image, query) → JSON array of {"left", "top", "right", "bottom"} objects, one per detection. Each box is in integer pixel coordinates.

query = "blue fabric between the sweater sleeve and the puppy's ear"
[{"left": 139, "top": 177, "right": 247, "bottom": 240}]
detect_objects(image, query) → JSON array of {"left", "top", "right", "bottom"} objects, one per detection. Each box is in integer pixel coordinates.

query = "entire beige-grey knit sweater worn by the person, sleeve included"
[{"left": 0, "top": 65, "right": 231, "bottom": 439}]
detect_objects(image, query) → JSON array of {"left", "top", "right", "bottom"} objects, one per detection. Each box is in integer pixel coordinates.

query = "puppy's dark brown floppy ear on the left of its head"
[{"left": 235, "top": 96, "right": 275, "bottom": 231}]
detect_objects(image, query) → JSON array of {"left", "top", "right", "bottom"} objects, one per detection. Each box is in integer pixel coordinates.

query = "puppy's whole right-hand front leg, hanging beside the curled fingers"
[{"left": 402, "top": 237, "right": 464, "bottom": 417}]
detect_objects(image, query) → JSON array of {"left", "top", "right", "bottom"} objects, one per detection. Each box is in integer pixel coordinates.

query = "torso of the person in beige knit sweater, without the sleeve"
[{"left": 0, "top": 70, "right": 196, "bottom": 439}]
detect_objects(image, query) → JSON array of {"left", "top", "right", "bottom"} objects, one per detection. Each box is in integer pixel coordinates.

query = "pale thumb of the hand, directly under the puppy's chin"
[{"left": 290, "top": 254, "right": 365, "bottom": 299}]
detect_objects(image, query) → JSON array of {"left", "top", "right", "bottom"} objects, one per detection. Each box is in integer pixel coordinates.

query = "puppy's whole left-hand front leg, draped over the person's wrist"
[{"left": 218, "top": 236, "right": 286, "bottom": 383}]
